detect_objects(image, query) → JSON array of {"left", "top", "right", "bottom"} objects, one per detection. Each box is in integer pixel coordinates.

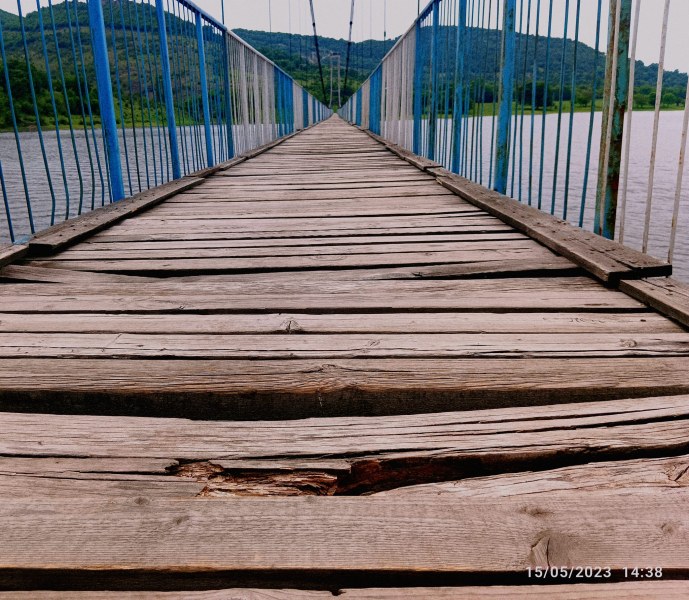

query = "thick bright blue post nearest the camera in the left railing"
[{"left": 88, "top": 0, "right": 124, "bottom": 202}]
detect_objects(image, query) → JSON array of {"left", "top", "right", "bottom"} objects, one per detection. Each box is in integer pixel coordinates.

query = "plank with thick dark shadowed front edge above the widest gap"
[{"left": 0, "top": 357, "right": 689, "bottom": 418}]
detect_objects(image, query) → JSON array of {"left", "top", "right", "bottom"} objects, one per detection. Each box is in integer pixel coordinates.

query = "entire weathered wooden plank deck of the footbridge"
[{"left": 0, "top": 117, "right": 689, "bottom": 600}]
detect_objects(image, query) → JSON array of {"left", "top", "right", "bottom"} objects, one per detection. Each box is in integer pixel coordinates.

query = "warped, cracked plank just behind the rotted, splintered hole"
[{"left": 0, "top": 395, "right": 689, "bottom": 460}]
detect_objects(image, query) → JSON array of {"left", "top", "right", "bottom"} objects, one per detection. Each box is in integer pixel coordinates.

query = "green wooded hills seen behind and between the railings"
[{"left": 0, "top": 0, "right": 687, "bottom": 130}]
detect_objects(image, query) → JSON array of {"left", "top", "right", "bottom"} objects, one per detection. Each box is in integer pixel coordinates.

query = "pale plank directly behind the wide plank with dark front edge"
[{"left": 0, "top": 332, "right": 689, "bottom": 360}]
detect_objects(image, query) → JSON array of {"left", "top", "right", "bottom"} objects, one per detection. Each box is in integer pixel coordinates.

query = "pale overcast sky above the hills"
[{"left": 0, "top": 0, "right": 689, "bottom": 72}]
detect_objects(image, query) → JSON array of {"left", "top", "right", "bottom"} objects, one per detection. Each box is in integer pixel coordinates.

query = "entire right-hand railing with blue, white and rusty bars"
[{"left": 340, "top": 0, "right": 689, "bottom": 278}]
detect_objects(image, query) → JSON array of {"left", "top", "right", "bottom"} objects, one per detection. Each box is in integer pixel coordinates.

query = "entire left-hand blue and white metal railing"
[{"left": 0, "top": 0, "right": 331, "bottom": 242}]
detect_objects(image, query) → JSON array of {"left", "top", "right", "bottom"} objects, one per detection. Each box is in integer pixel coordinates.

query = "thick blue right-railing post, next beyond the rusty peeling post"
[{"left": 493, "top": 0, "right": 517, "bottom": 194}]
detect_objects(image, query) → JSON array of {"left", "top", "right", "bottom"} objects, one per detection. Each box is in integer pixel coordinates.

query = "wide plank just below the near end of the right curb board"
[{"left": 0, "top": 276, "right": 643, "bottom": 313}]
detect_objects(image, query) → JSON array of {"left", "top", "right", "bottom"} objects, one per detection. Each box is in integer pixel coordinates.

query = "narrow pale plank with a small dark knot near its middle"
[{"left": 0, "top": 312, "right": 668, "bottom": 335}]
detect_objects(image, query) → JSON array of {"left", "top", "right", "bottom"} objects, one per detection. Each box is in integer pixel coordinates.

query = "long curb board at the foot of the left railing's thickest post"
[{"left": 28, "top": 177, "right": 205, "bottom": 256}]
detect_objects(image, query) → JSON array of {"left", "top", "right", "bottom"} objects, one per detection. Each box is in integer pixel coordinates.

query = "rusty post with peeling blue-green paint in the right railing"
[{"left": 593, "top": 0, "right": 632, "bottom": 239}]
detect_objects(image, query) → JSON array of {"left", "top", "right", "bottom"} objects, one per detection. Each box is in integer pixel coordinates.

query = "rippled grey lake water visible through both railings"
[{"left": 0, "top": 111, "right": 689, "bottom": 281}]
